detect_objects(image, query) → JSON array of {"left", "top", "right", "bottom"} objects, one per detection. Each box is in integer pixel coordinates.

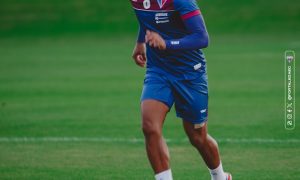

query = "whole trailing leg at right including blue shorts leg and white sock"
[{"left": 173, "top": 75, "right": 231, "bottom": 180}]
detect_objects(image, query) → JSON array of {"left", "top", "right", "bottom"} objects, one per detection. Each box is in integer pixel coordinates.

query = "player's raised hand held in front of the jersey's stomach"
[{"left": 146, "top": 30, "right": 167, "bottom": 50}]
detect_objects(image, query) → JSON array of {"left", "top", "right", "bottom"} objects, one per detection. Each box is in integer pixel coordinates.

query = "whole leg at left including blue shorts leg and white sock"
[{"left": 141, "top": 72, "right": 174, "bottom": 180}]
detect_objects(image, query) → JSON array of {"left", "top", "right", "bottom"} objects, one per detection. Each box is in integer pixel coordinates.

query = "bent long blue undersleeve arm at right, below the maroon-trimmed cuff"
[{"left": 165, "top": 15, "right": 209, "bottom": 50}]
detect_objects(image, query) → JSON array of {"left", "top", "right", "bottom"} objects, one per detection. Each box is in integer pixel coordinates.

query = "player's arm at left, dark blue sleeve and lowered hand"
[{"left": 132, "top": 26, "right": 147, "bottom": 67}]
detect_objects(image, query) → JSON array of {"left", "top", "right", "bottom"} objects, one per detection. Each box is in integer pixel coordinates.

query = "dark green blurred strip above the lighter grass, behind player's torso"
[{"left": 0, "top": 0, "right": 300, "bottom": 37}]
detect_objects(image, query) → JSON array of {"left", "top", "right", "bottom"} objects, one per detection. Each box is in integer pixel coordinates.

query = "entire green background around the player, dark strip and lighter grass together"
[{"left": 0, "top": 0, "right": 300, "bottom": 180}]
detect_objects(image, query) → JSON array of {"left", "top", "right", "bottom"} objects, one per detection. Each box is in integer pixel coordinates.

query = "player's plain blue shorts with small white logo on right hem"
[{"left": 141, "top": 72, "right": 208, "bottom": 124}]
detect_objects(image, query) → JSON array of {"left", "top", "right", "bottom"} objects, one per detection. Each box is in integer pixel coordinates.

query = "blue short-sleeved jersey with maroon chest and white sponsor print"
[{"left": 131, "top": 0, "right": 206, "bottom": 80}]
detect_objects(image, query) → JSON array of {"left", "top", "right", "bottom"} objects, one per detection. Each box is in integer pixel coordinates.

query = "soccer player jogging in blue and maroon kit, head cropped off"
[{"left": 130, "top": 0, "right": 232, "bottom": 180}]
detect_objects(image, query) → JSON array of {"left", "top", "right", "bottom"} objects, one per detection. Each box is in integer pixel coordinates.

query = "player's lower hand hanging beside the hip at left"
[{"left": 132, "top": 43, "right": 147, "bottom": 67}]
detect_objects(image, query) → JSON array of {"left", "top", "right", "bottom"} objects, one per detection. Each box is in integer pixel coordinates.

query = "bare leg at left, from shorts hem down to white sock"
[{"left": 141, "top": 100, "right": 170, "bottom": 174}]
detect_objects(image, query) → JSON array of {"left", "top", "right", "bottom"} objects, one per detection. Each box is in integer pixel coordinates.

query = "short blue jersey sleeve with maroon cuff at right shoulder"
[{"left": 174, "top": 0, "right": 201, "bottom": 20}]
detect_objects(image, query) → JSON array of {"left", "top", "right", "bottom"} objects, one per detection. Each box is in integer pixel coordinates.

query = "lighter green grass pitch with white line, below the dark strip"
[{"left": 0, "top": 35, "right": 300, "bottom": 180}]
